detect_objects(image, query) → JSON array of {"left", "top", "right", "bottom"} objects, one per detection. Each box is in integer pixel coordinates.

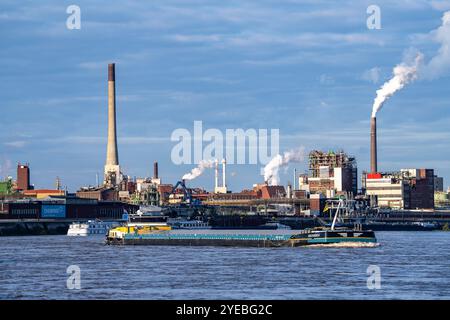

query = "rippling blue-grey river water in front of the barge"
[{"left": 0, "top": 231, "right": 450, "bottom": 299}]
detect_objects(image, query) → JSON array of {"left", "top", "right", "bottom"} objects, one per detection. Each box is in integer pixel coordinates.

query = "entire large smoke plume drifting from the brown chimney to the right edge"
[{"left": 372, "top": 11, "right": 450, "bottom": 117}]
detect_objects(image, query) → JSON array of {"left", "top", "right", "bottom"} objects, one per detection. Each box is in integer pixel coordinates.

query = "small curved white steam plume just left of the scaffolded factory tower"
[{"left": 264, "top": 147, "right": 305, "bottom": 186}]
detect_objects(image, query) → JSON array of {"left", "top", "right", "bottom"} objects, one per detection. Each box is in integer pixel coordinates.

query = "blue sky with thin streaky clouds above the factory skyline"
[{"left": 0, "top": 0, "right": 450, "bottom": 191}]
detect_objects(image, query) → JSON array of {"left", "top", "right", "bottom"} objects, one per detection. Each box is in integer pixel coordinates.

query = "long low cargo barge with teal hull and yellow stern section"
[{"left": 106, "top": 228, "right": 377, "bottom": 247}]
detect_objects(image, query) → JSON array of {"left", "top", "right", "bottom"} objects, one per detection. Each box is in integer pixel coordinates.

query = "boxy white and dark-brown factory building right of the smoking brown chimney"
[{"left": 365, "top": 169, "right": 434, "bottom": 209}]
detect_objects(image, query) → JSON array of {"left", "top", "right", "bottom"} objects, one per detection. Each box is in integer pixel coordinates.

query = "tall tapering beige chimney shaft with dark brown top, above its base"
[{"left": 106, "top": 63, "right": 119, "bottom": 165}]
